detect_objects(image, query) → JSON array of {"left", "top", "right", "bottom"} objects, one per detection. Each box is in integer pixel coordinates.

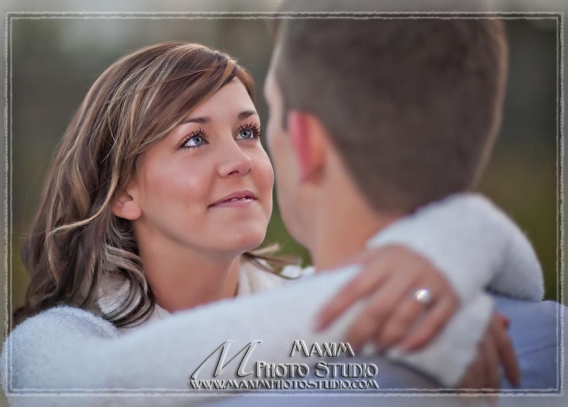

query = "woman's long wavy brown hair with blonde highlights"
[{"left": 14, "top": 42, "right": 288, "bottom": 327}]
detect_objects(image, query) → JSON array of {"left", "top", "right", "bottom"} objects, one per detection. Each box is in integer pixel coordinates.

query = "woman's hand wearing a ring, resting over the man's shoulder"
[{"left": 318, "top": 245, "right": 459, "bottom": 352}]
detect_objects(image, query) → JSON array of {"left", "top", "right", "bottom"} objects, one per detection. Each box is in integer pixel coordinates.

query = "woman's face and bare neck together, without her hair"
[{"left": 113, "top": 79, "right": 274, "bottom": 311}]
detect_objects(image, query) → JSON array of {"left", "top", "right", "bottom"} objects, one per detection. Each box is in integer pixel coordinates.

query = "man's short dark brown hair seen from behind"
[{"left": 275, "top": 6, "right": 508, "bottom": 212}]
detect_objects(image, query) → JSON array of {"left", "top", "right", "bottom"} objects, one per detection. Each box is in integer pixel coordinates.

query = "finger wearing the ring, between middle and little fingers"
[{"left": 375, "top": 298, "right": 425, "bottom": 348}]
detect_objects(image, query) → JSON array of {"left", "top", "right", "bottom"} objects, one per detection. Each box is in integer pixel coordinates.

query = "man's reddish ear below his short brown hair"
[{"left": 287, "top": 110, "right": 325, "bottom": 182}]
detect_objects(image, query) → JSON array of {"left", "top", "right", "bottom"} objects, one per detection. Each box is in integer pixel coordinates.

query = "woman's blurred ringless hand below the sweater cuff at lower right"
[{"left": 458, "top": 312, "right": 521, "bottom": 390}]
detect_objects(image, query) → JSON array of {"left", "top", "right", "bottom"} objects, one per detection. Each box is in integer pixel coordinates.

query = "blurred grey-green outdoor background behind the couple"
[{"left": 6, "top": 14, "right": 559, "bottom": 318}]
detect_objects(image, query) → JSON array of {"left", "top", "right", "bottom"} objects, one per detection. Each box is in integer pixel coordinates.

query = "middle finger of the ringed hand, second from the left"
[{"left": 347, "top": 278, "right": 420, "bottom": 348}]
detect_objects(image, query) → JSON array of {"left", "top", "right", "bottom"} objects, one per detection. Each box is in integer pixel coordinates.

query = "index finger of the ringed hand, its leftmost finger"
[{"left": 316, "top": 264, "right": 388, "bottom": 331}]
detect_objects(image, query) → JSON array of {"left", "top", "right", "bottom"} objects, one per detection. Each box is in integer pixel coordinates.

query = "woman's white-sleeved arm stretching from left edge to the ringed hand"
[{"left": 1, "top": 268, "right": 364, "bottom": 405}]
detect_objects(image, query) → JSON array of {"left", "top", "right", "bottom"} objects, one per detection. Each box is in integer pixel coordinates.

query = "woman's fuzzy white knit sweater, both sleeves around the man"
[{"left": 1, "top": 195, "right": 543, "bottom": 406}]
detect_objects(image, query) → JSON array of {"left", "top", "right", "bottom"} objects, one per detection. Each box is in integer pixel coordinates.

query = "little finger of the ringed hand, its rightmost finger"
[{"left": 399, "top": 298, "right": 455, "bottom": 352}]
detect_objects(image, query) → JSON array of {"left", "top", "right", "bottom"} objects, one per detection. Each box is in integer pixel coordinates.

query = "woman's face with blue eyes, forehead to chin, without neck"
[{"left": 122, "top": 79, "right": 274, "bottom": 253}]
